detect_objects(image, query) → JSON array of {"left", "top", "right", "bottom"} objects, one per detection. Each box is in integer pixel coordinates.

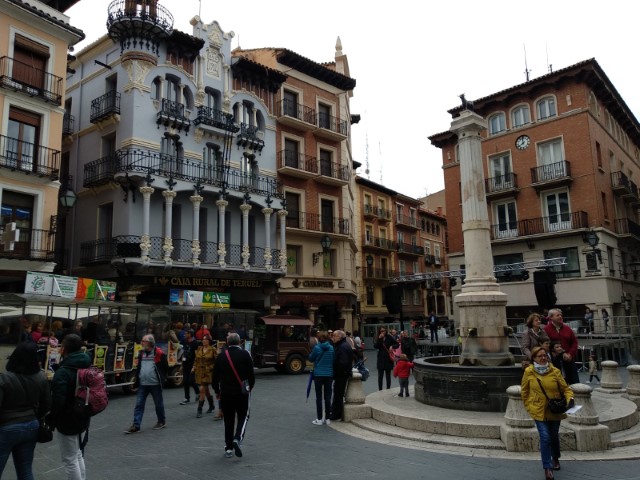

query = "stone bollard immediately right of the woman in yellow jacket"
[{"left": 567, "top": 382, "right": 617, "bottom": 452}]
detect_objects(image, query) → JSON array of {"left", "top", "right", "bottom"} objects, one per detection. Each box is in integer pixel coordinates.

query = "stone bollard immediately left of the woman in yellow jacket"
[{"left": 500, "top": 385, "right": 539, "bottom": 452}]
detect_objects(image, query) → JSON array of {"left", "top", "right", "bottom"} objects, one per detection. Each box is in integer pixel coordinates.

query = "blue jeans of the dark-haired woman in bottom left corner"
[{"left": 0, "top": 419, "right": 38, "bottom": 480}]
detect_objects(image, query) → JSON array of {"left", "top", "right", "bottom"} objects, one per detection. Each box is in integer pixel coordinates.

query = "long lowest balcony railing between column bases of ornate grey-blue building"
[{"left": 80, "top": 235, "right": 280, "bottom": 270}]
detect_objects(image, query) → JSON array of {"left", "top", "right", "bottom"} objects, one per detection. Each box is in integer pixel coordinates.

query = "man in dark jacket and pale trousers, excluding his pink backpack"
[{"left": 47, "top": 333, "right": 91, "bottom": 480}]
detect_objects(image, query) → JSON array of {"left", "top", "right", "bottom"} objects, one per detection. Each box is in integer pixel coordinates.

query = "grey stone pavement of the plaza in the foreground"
[{"left": 2, "top": 368, "right": 640, "bottom": 480}]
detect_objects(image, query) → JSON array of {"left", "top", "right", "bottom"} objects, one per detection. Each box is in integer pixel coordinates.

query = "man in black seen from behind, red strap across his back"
[{"left": 212, "top": 333, "right": 255, "bottom": 458}]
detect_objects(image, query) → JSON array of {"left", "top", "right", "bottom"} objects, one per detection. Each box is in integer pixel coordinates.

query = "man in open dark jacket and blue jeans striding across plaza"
[{"left": 124, "top": 334, "right": 169, "bottom": 433}]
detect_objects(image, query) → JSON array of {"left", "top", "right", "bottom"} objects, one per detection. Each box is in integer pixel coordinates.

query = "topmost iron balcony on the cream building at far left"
[{"left": 0, "top": 57, "right": 62, "bottom": 105}]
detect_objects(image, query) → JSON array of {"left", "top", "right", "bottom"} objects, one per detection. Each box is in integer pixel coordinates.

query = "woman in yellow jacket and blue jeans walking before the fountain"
[{"left": 521, "top": 347, "right": 574, "bottom": 480}]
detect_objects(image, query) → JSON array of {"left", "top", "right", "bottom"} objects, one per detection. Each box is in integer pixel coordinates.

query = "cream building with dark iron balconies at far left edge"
[{"left": 0, "top": 0, "right": 84, "bottom": 292}]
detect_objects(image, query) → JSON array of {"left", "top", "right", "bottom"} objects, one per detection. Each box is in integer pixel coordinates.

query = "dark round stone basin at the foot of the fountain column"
[{"left": 413, "top": 355, "right": 522, "bottom": 412}]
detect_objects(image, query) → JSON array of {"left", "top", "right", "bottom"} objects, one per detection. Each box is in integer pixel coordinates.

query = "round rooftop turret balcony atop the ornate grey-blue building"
[{"left": 107, "top": 0, "right": 173, "bottom": 55}]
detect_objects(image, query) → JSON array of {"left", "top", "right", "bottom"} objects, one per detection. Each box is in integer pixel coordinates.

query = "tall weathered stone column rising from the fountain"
[{"left": 451, "top": 110, "right": 514, "bottom": 366}]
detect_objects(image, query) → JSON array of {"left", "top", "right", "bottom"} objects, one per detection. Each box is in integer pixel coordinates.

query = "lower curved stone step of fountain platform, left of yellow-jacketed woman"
[{"left": 351, "top": 418, "right": 505, "bottom": 450}]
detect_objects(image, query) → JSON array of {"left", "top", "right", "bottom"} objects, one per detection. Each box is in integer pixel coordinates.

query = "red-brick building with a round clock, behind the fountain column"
[{"left": 430, "top": 59, "right": 640, "bottom": 331}]
